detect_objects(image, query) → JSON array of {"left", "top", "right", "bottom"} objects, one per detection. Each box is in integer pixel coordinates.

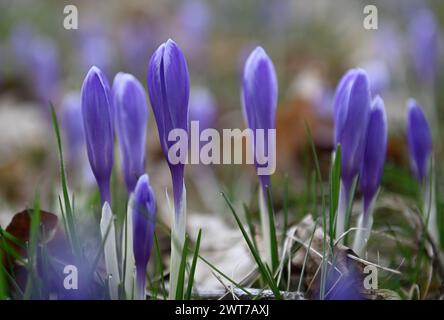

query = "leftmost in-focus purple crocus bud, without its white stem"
[{"left": 81, "top": 67, "right": 114, "bottom": 204}]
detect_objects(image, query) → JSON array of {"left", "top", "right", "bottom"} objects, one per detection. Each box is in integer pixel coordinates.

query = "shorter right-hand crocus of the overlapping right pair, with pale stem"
[{"left": 353, "top": 96, "right": 387, "bottom": 255}]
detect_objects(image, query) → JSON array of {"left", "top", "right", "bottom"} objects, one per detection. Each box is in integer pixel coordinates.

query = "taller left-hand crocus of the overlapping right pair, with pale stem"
[{"left": 333, "top": 69, "right": 371, "bottom": 236}]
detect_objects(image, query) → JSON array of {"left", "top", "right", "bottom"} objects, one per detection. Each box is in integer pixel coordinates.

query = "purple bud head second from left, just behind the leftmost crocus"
[{"left": 112, "top": 73, "right": 148, "bottom": 193}]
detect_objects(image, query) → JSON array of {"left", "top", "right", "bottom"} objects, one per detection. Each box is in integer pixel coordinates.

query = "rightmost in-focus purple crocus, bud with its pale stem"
[{"left": 407, "top": 99, "right": 439, "bottom": 243}]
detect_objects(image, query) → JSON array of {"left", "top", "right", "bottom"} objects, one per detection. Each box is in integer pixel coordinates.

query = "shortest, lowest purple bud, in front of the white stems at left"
[{"left": 132, "top": 174, "right": 156, "bottom": 299}]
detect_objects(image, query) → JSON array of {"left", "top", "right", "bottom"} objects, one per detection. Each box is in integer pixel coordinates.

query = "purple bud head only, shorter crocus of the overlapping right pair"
[{"left": 360, "top": 96, "right": 387, "bottom": 214}]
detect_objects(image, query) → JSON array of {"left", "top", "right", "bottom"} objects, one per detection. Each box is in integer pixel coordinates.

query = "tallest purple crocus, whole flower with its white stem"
[{"left": 148, "top": 39, "right": 190, "bottom": 298}]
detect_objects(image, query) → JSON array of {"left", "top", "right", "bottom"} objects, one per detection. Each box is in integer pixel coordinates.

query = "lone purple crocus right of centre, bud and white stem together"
[{"left": 242, "top": 47, "right": 278, "bottom": 267}]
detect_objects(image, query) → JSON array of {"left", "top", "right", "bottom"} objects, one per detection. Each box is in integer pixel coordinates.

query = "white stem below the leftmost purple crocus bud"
[{"left": 100, "top": 202, "right": 120, "bottom": 300}]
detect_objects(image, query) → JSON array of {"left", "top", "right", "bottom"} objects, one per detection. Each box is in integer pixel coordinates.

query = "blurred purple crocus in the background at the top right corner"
[{"left": 408, "top": 8, "right": 439, "bottom": 81}]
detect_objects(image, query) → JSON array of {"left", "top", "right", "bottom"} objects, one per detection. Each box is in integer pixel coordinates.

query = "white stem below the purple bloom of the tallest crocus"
[{"left": 169, "top": 185, "right": 187, "bottom": 300}]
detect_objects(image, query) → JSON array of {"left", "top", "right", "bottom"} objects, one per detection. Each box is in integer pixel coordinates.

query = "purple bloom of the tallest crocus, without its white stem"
[{"left": 148, "top": 39, "right": 190, "bottom": 215}]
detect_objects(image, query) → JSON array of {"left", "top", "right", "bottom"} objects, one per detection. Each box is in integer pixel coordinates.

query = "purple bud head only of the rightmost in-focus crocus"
[{"left": 407, "top": 99, "right": 432, "bottom": 182}]
